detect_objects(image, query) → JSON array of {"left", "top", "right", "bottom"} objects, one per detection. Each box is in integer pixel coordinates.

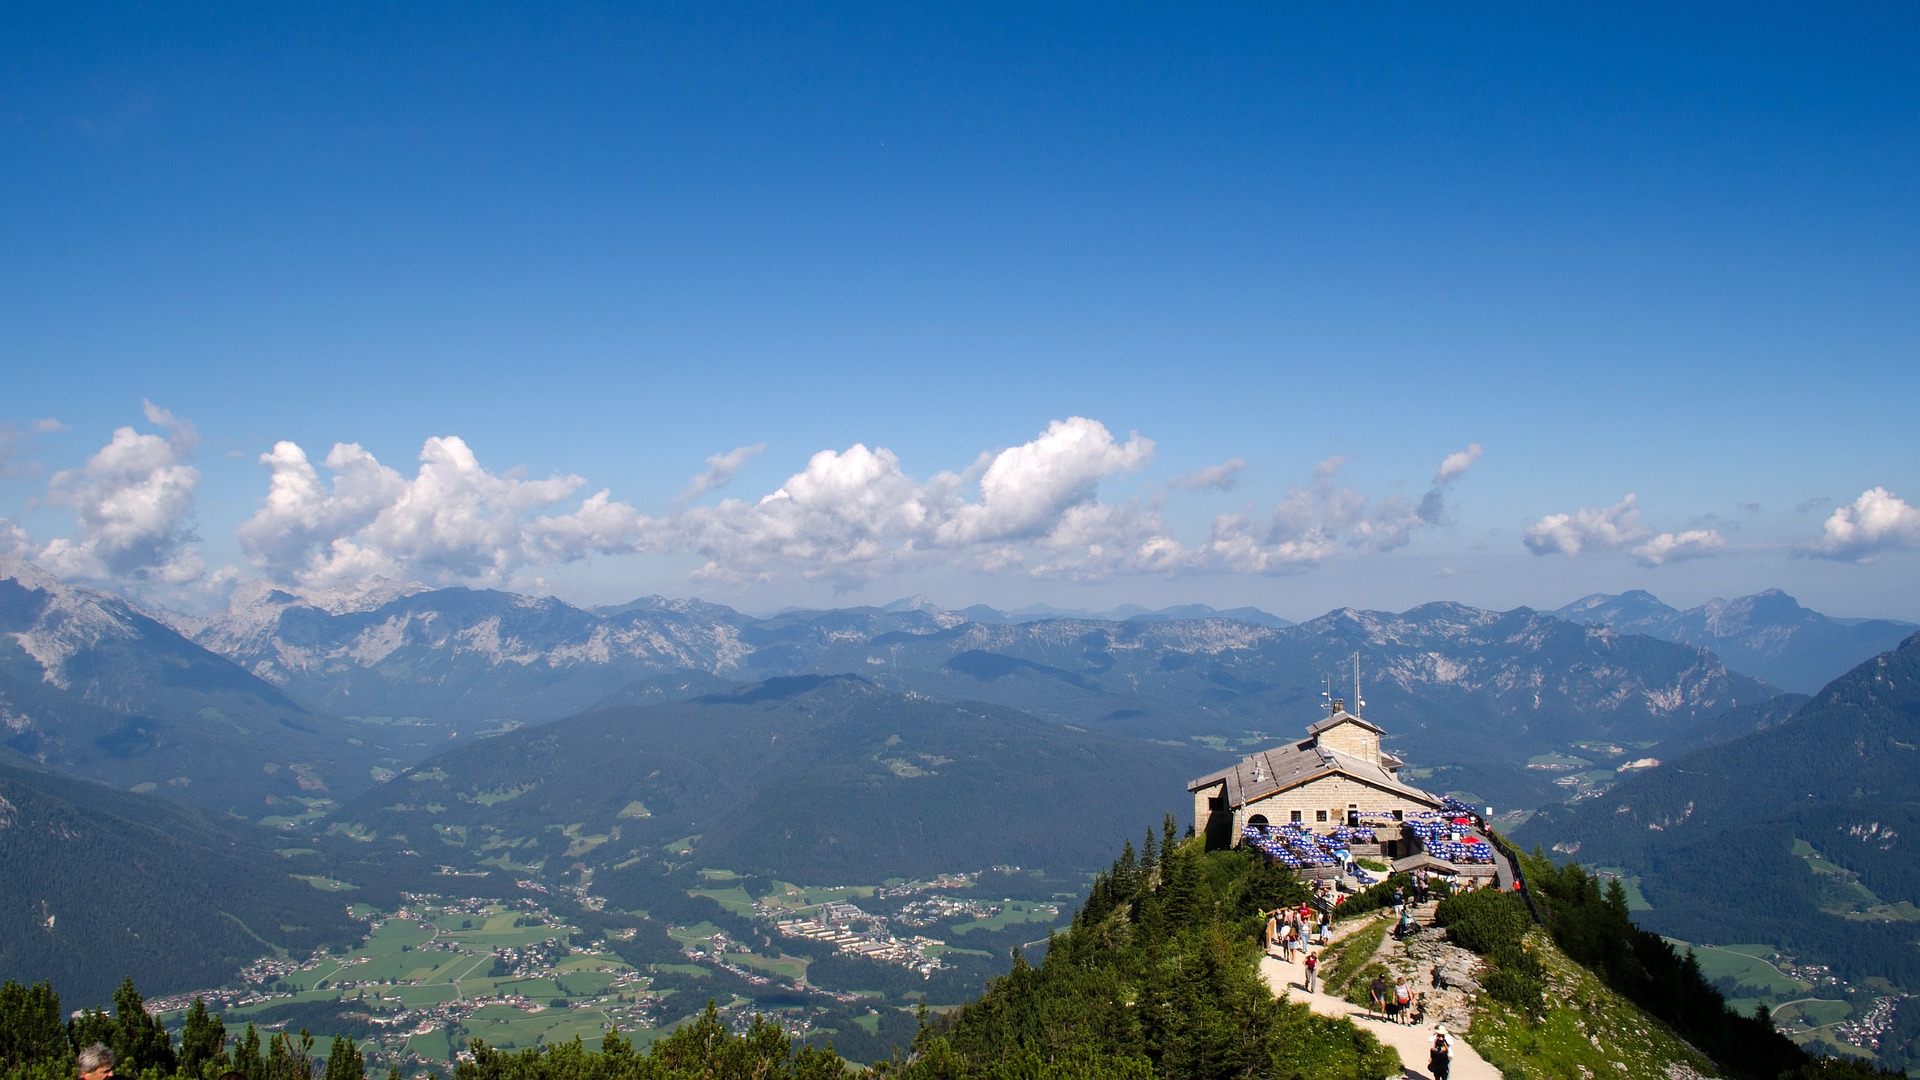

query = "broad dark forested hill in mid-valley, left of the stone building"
[{"left": 338, "top": 676, "right": 1223, "bottom": 882}]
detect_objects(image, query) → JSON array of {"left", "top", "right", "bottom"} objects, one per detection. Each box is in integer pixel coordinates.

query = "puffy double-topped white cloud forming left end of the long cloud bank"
[{"left": 236, "top": 436, "right": 643, "bottom": 586}]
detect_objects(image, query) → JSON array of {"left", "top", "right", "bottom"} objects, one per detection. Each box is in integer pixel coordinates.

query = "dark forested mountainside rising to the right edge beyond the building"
[{"left": 1517, "top": 636, "right": 1920, "bottom": 1042}]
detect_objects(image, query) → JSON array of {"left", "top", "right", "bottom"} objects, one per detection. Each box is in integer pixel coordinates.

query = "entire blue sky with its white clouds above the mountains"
[{"left": 0, "top": 4, "right": 1920, "bottom": 619}]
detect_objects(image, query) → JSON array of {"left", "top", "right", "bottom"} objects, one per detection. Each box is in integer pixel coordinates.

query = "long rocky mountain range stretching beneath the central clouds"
[{"left": 176, "top": 572, "right": 1774, "bottom": 805}]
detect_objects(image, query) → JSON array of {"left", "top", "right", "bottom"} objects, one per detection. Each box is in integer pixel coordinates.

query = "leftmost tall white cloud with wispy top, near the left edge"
[{"left": 38, "top": 402, "right": 202, "bottom": 582}]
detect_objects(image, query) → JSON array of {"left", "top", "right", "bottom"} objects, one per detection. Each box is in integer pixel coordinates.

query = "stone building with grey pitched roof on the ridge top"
[{"left": 1187, "top": 700, "right": 1442, "bottom": 855}]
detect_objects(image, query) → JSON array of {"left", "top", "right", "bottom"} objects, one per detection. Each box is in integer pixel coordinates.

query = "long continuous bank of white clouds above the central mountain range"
[{"left": 220, "top": 417, "right": 1476, "bottom": 588}]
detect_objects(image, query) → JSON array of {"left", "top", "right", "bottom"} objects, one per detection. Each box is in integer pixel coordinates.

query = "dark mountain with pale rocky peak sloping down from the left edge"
[{"left": 0, "top": 555, "right": 386, "bottom": 817}]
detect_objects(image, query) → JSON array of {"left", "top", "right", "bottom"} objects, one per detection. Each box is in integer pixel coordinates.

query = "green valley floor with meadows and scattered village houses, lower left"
[{"left": 146, "top": 867, "right": 1064, "bottom": 1072}]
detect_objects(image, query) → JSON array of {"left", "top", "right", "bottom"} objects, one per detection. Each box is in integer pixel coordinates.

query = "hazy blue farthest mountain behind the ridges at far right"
[{"left": 1553, "top": 588, "right": 1920, "bottom": 694}]
